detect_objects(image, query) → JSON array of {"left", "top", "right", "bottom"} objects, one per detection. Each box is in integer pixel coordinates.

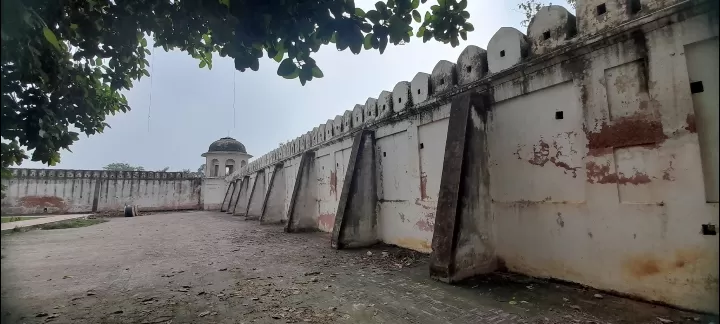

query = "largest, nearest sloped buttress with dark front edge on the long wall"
[{"left": 430, "top": 93, "right": 497, "bottom": 283}]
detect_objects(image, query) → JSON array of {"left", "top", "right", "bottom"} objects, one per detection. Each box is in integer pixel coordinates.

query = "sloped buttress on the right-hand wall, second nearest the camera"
[{"left": 331, "top": 130, "right": 378, "bottom": 249}]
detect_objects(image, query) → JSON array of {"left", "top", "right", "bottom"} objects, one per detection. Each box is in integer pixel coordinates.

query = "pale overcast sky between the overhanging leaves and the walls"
[{"left": 22, "top": 0, "right": 574, "bottom": 171}]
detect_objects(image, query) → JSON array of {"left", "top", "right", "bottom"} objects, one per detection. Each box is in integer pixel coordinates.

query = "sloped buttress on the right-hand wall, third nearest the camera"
[{"left": 285, "top": 151, "right": 318, "bottom": 233}]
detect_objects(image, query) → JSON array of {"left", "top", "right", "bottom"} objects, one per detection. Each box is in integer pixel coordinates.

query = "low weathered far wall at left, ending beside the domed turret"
[{"left": 2, "top": 169, "right": 201, "bottom": 215}]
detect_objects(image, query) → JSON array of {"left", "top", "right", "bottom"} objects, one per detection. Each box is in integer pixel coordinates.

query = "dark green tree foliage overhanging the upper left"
[{"left": 0, "top": 0, "right": 474, "bottom": 176}]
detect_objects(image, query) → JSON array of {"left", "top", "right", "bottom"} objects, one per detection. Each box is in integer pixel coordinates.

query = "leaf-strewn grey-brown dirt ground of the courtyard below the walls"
[{"left": 2, "top": 212, "right": 718, "bottom": 324}]
